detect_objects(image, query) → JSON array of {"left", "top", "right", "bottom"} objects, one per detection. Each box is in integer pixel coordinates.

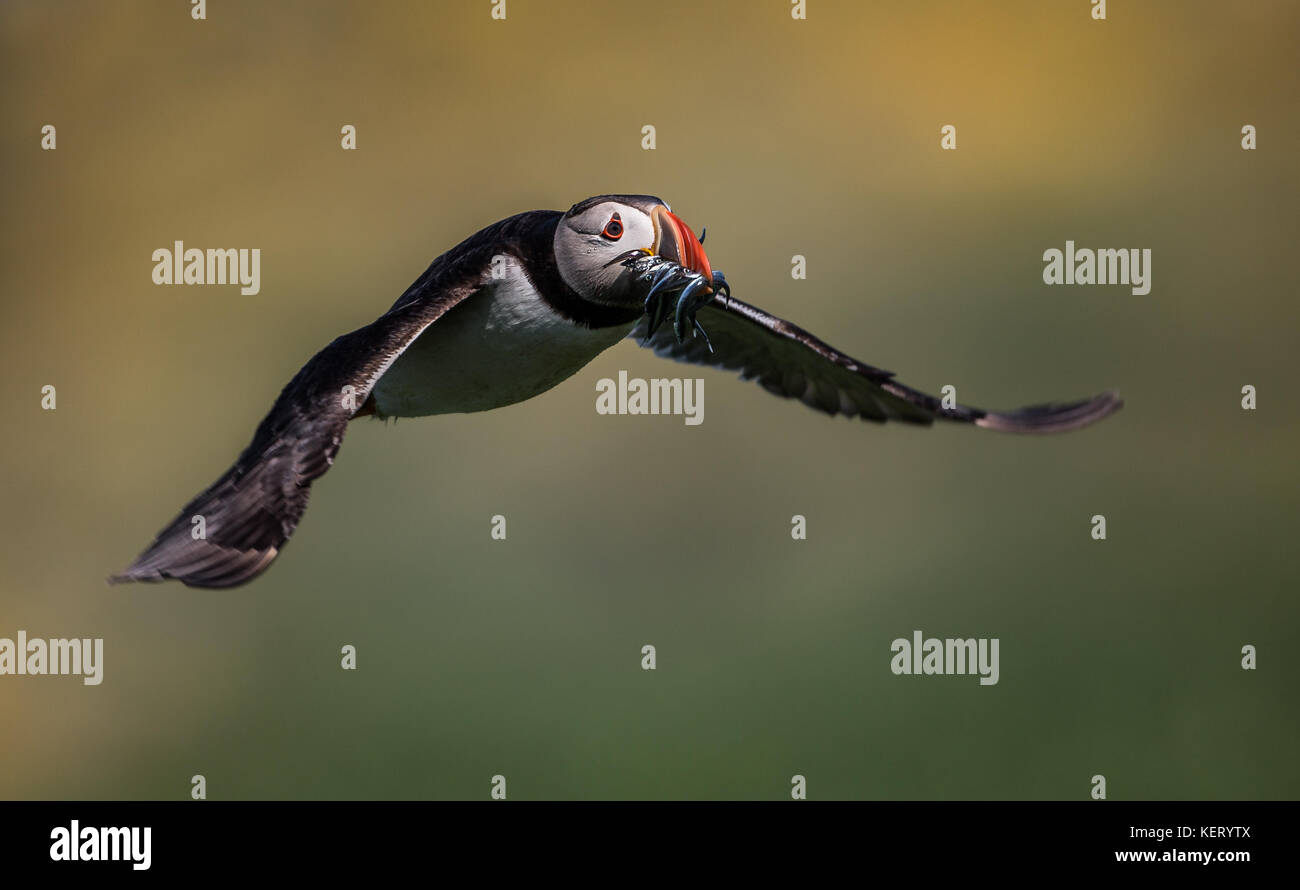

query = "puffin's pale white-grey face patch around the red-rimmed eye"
[{"left": 555, "top": 200, "right": 655, "bottom": 305}]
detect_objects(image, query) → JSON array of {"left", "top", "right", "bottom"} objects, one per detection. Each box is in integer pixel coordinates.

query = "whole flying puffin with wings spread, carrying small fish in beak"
[{"left": 108, "top": 195, "right": 1122, "bottom": 587}]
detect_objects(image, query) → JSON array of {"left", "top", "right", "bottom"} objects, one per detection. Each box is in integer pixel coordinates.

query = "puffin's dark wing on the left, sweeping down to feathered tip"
[{"left": 109, "top": 210, "right": 559, "bottom": 587}]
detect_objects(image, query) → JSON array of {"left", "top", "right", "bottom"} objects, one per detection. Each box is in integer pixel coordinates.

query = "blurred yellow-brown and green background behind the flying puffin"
[{"left": 0, "top": 0, "right": 1300, "bottom": 799}]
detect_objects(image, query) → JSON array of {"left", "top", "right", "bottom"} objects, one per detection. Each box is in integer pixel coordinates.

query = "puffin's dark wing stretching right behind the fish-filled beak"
[{"left": 628, "top": 294, "right": 1123, "bottom": 433}]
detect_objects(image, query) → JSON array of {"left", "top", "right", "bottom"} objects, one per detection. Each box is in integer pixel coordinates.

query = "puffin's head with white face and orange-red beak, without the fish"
[{"left": 555, "top": 195, "right": 714, "bottom": 305}]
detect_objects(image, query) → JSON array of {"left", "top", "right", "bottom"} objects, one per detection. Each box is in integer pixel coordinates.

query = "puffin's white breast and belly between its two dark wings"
[{"left": 374, "top": 257, "right": 634, "bottom": 417}]
